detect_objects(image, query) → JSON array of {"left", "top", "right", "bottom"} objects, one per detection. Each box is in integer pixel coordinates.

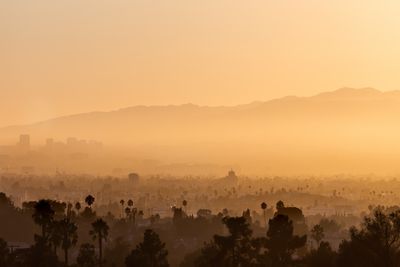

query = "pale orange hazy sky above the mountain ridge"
[{"left": 0, "top": 0, "right": 400, "bottom": 125}]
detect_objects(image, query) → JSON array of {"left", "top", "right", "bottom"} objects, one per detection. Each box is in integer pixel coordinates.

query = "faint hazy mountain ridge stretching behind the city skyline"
[{"left": 0, "top": 88, "right": 400, "bottom": 149}]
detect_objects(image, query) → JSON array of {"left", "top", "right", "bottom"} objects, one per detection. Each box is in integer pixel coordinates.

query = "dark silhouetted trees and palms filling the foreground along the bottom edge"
[{"left": 0, "top": 193, "right": 400, "bottom": 267}]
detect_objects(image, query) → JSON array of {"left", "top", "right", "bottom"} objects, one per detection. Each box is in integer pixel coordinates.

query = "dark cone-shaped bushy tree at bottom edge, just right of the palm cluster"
[{"left": 125, "top": 229, "right": 169, "bottom": 267}]
